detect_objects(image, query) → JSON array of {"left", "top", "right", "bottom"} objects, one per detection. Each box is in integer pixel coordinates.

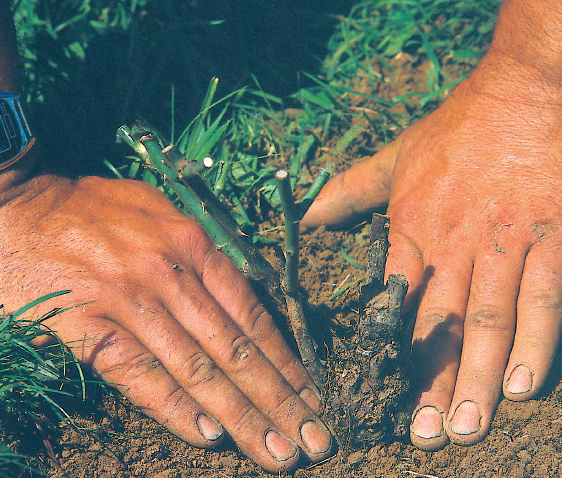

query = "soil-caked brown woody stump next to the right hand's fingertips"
[{"left": 325, "top": 214, "right": 411, "bottom": 446}]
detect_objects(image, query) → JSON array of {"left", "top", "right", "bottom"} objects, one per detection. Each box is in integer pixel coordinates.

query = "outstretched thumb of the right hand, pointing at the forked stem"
[{"left": 300, "top": 138, "right": 402, "bottom": 231}]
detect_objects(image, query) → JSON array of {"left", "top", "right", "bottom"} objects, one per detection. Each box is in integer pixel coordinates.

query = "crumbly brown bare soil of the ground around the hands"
[{"left": 6, "top": 55, "right": 562, "bottom": 478}]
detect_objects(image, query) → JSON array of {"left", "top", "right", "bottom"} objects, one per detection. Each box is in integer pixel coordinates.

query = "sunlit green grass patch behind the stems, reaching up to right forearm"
[{"left": 117, "top": 0, "right": 499, "bottom": 243}]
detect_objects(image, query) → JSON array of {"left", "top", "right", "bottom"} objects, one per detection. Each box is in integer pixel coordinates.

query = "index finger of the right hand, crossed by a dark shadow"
[{"left": 404, "top": 250, "right": 472, "bottom": 451}]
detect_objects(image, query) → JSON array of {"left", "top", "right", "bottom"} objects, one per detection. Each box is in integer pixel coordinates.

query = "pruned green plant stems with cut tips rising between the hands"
[{"left": 118, "top": 125, "right": 329, "bottom": 390}]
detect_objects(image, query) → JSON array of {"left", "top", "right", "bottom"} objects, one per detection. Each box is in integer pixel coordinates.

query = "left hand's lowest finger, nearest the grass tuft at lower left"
[{"left": 48, "top": 311, "right": 224, "bottom": 448}]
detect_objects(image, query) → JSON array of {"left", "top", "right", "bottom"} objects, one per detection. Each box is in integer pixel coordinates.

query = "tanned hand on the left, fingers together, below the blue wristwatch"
[{"left": 0, "top": 176, "right": 331, "bottom": 472}]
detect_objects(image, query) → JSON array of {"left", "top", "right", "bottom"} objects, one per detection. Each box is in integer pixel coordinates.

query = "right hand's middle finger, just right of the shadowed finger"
[{"left": 446, "top": 240, "right": 525, "bottom": 445}]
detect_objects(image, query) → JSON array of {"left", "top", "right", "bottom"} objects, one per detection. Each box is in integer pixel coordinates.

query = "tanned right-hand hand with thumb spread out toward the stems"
[{"left": 301, "top": 51, "right": 562, "bottom": 450}]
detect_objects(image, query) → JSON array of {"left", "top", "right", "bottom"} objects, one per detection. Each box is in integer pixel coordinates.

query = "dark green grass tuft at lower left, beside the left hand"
[{"left": 0, "top": 291, "right": 84, "bottom": 476}]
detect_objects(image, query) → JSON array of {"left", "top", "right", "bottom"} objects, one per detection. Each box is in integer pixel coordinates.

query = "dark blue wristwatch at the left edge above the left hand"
[{"left": 0, "top": 92, "right": 35, "bottom": 170}]
